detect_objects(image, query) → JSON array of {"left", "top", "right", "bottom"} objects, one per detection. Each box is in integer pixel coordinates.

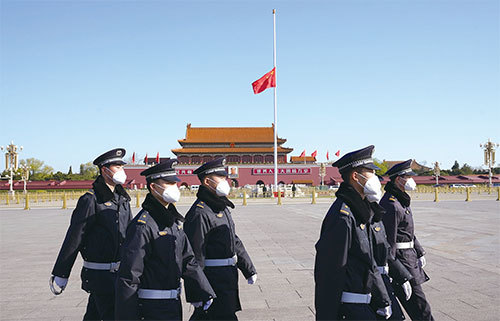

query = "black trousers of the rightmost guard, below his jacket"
[{"left": 394, "top": 284, "right": 434, "bottom": 321}]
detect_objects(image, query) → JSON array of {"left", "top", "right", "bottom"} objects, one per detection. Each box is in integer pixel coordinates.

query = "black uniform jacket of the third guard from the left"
[{"left": 184, "top": 186, "right": 257, "bottom": 314}]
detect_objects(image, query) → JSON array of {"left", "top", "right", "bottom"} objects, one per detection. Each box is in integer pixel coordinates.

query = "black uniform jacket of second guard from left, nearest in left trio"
[{"left": 115, "top": 194, "right": 215, "bottom": 320}]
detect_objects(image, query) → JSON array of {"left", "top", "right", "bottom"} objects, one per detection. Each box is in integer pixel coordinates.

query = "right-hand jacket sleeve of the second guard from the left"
[{"left": 182, "top": 230, "right": 216, "bottom": 302}]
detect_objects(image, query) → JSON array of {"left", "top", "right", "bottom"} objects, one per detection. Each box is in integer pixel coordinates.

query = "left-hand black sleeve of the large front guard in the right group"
[{"left": 314, "top": 213, "right": 352, "bottom": 320}]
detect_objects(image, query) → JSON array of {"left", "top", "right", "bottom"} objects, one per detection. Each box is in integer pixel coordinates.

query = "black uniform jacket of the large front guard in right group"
[{"left": 314, "top": 183, "right": 391, "bottom": 320}]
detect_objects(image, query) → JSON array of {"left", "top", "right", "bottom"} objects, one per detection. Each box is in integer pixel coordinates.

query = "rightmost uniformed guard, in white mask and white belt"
[{"left": 380, "top": 159, "right": 434, "bottom": 320}]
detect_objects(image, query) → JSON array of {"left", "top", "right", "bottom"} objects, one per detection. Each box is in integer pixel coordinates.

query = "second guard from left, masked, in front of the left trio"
[{"left": 116, "top": 159, "right": 215, "bottom": 320}]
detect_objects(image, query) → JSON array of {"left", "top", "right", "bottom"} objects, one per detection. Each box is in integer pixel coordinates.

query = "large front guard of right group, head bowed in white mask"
[{"left": 314, "top": 146, "right": 391, "bottom": 320}]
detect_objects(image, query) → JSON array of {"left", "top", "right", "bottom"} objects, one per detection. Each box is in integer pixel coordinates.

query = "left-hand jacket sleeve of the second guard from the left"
[{"left": 115, "top": 222, "right": 149, "bottom": 320}]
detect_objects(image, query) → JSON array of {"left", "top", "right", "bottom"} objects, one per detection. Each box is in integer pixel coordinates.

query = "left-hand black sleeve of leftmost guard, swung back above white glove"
[{"left": 52, "top": 192, "right": 95, "bottom": 278}]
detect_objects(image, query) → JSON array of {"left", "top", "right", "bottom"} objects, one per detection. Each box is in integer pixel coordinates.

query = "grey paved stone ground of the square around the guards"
[{"left": 0, "top": 198, "right": 500, "bottom": 321}]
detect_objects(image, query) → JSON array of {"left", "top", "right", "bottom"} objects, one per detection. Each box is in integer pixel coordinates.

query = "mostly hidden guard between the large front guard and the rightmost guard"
[{"left": 370, "top": 202, "right": 413, "bottom": 320}]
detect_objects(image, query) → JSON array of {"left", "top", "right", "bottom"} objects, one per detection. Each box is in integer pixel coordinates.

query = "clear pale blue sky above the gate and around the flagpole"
[{"left": 0, "top": 0, "right": 500, "bottom": 172}]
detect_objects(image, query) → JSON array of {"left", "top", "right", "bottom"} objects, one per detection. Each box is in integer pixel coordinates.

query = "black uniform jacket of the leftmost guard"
[{"left": 52, "top": 176, "right": 132, "bottom": 293}]
